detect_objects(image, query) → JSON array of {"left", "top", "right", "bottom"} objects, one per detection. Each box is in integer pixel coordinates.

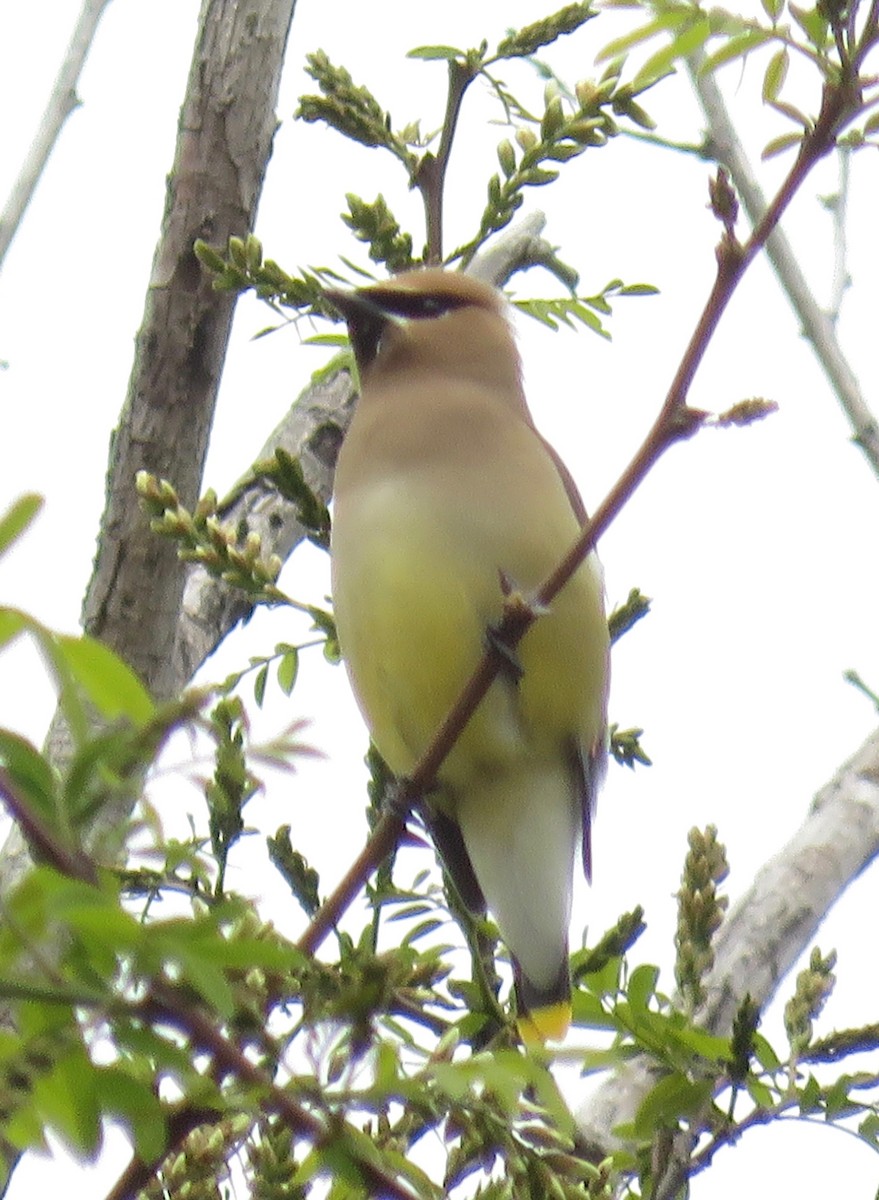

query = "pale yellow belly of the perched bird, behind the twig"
[{"left": 334, "top": 480, "right": 608, "bottom": 791}]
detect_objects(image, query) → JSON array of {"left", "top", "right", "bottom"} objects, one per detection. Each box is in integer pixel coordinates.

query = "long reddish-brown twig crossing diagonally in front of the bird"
[{"left": 298, "top": 75, "right": 859, "bottom": 953}]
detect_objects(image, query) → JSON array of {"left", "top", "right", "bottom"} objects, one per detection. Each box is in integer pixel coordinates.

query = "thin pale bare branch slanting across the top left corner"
[{"left": 0, "top": 0, "right": 110, "bottom": 269}]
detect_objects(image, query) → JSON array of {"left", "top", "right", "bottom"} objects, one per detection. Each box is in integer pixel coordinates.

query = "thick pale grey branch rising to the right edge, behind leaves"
[{"left": 578, "top": 730, "right": 879, "bottom": 1157}]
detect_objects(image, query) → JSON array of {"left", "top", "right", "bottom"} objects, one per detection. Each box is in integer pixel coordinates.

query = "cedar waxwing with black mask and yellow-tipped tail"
[{"left": 330, "top": 269, "right": 609, "bottom": 1042}]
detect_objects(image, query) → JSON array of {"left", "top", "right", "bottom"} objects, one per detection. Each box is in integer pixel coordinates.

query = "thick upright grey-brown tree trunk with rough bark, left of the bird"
[{"left": 83, "top": 0, "right": 295, "bottom": 700}]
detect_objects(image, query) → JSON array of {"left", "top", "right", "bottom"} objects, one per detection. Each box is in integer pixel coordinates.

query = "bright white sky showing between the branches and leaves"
[{"left": 0, "top": 0, "right": 879, "bottom": 1200}]
